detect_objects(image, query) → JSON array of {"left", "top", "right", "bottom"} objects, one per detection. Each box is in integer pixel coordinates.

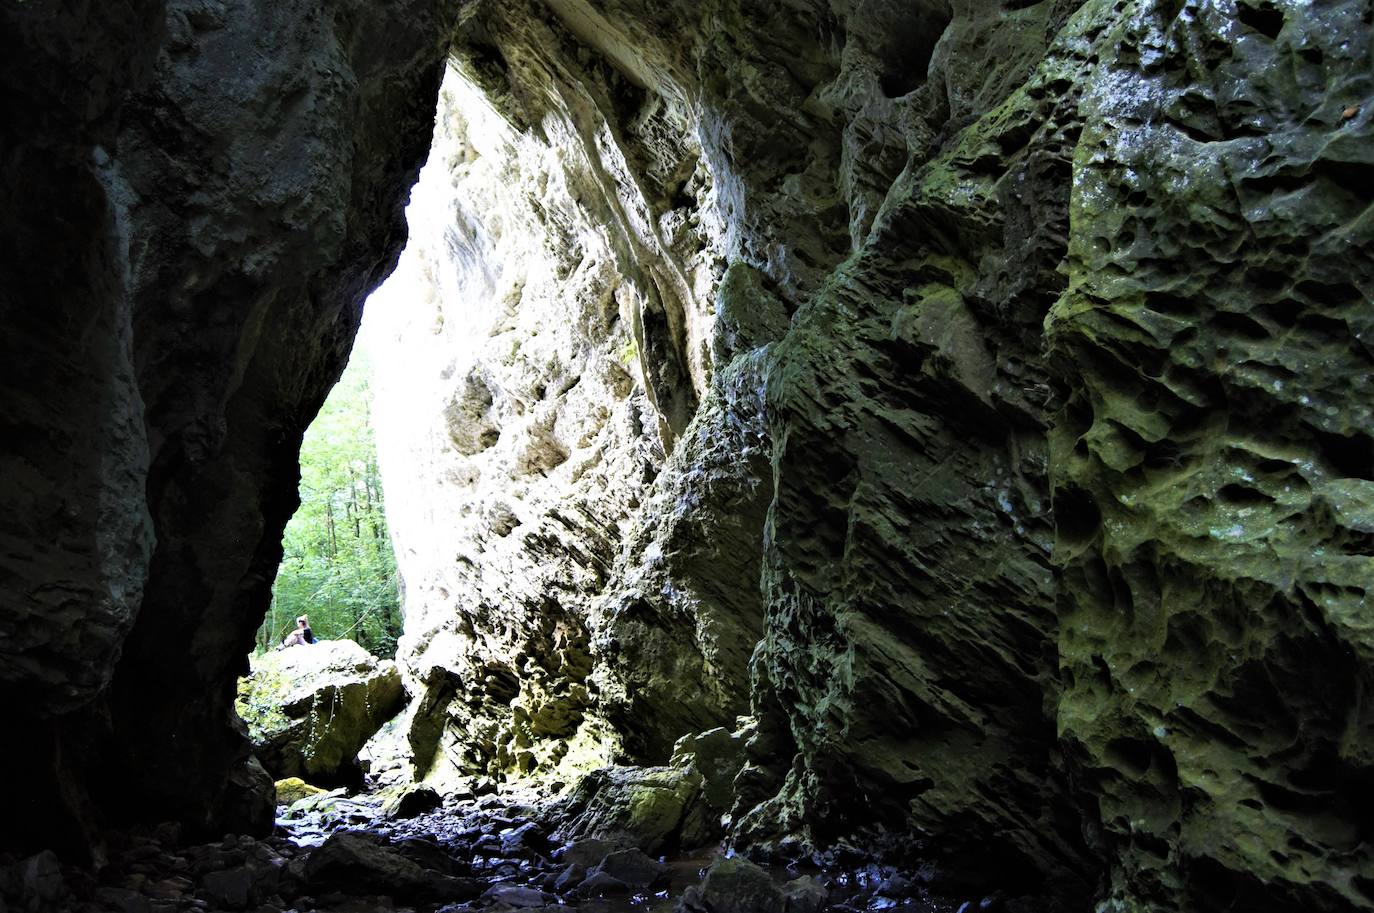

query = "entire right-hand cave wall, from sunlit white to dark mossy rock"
[{"left": 383, "top": 0, "right": 1374, "bottom": 910}]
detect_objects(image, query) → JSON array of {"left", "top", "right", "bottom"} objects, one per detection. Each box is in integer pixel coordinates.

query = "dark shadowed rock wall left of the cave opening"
[{"left": 0, "top": 0, "right": 453, "bottom": 850}]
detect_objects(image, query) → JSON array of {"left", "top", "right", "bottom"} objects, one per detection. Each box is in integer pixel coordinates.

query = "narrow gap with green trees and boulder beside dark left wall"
[{"left": 236, "top": 306, "right": 405, "bottom": 804}]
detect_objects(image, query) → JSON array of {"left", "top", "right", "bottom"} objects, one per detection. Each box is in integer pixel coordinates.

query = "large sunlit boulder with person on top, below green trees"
[{"left": 236, "top": 641, "right": 405, "bottom": 785}]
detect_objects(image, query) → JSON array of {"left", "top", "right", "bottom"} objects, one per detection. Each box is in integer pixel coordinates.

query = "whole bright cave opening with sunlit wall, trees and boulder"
[{"left": 236, "top": 51, "right": 683, "bottom": 814}]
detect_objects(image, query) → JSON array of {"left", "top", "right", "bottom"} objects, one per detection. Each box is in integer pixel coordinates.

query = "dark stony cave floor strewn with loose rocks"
[{"left": 0, "top": 789, "right": 1022, "bottom": 913}]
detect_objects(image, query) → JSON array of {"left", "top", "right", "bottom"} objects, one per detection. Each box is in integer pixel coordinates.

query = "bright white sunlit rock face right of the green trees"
[{"left": 371, "top": 46, "right": 761, "bottom": 782}]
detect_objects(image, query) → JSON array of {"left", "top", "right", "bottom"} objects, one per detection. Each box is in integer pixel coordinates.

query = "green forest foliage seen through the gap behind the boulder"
[{"left": 257, "top": 352, "right": 401, "bottom": 657}]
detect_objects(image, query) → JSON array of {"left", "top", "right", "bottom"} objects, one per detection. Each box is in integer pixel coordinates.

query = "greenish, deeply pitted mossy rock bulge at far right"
[{"left": 1047, "top": 3, "right": 1374, "bottom": 910}]
